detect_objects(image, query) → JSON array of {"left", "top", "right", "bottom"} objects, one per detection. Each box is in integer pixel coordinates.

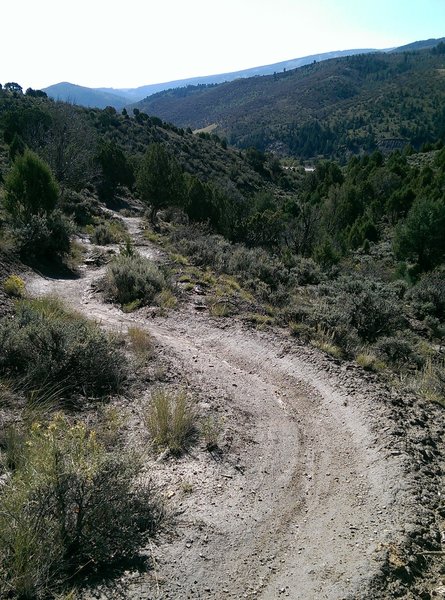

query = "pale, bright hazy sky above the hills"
[{"left": 0, "top": 0, "right": 445, "bottom": 88}]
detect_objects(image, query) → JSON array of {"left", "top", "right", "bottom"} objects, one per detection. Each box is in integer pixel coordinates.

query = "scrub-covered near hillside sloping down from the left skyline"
[{"left": 0, "top": 92, "right": 288, "bottom": 206}]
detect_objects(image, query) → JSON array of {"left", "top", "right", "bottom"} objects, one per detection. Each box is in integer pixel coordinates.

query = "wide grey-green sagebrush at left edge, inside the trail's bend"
[{"left": 0, "top": 298, "right": 126, "bottom": 396}]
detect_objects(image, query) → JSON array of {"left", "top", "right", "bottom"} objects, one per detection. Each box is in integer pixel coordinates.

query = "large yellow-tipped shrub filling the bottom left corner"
[{"left": 0, "top": 414, "right": 159, "bottom": 599}]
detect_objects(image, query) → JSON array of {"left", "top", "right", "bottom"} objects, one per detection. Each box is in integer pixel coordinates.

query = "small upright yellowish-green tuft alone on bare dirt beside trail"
[{"left": 145, "top": 389, "right": 195, "bottom": 454}]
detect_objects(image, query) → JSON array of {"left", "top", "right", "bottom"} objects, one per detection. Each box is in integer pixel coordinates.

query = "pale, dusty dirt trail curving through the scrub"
[{"left": 28, "top": 218, "right": 440, "bottom": 600}]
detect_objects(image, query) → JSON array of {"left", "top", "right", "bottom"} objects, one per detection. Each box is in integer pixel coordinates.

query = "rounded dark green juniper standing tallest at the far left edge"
[{"left": 5, "top": 150, "right": 59, "bottom": 223}]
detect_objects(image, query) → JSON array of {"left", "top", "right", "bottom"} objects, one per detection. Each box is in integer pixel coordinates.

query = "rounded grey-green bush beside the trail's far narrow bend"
[{"left": 103, "top": 254, "right": 166, "bottom": 305}]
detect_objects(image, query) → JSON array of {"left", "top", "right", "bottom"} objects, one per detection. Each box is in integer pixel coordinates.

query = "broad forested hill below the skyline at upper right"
[{"left": 137, "top": 44, "right": 445, "bottom": 159}]
